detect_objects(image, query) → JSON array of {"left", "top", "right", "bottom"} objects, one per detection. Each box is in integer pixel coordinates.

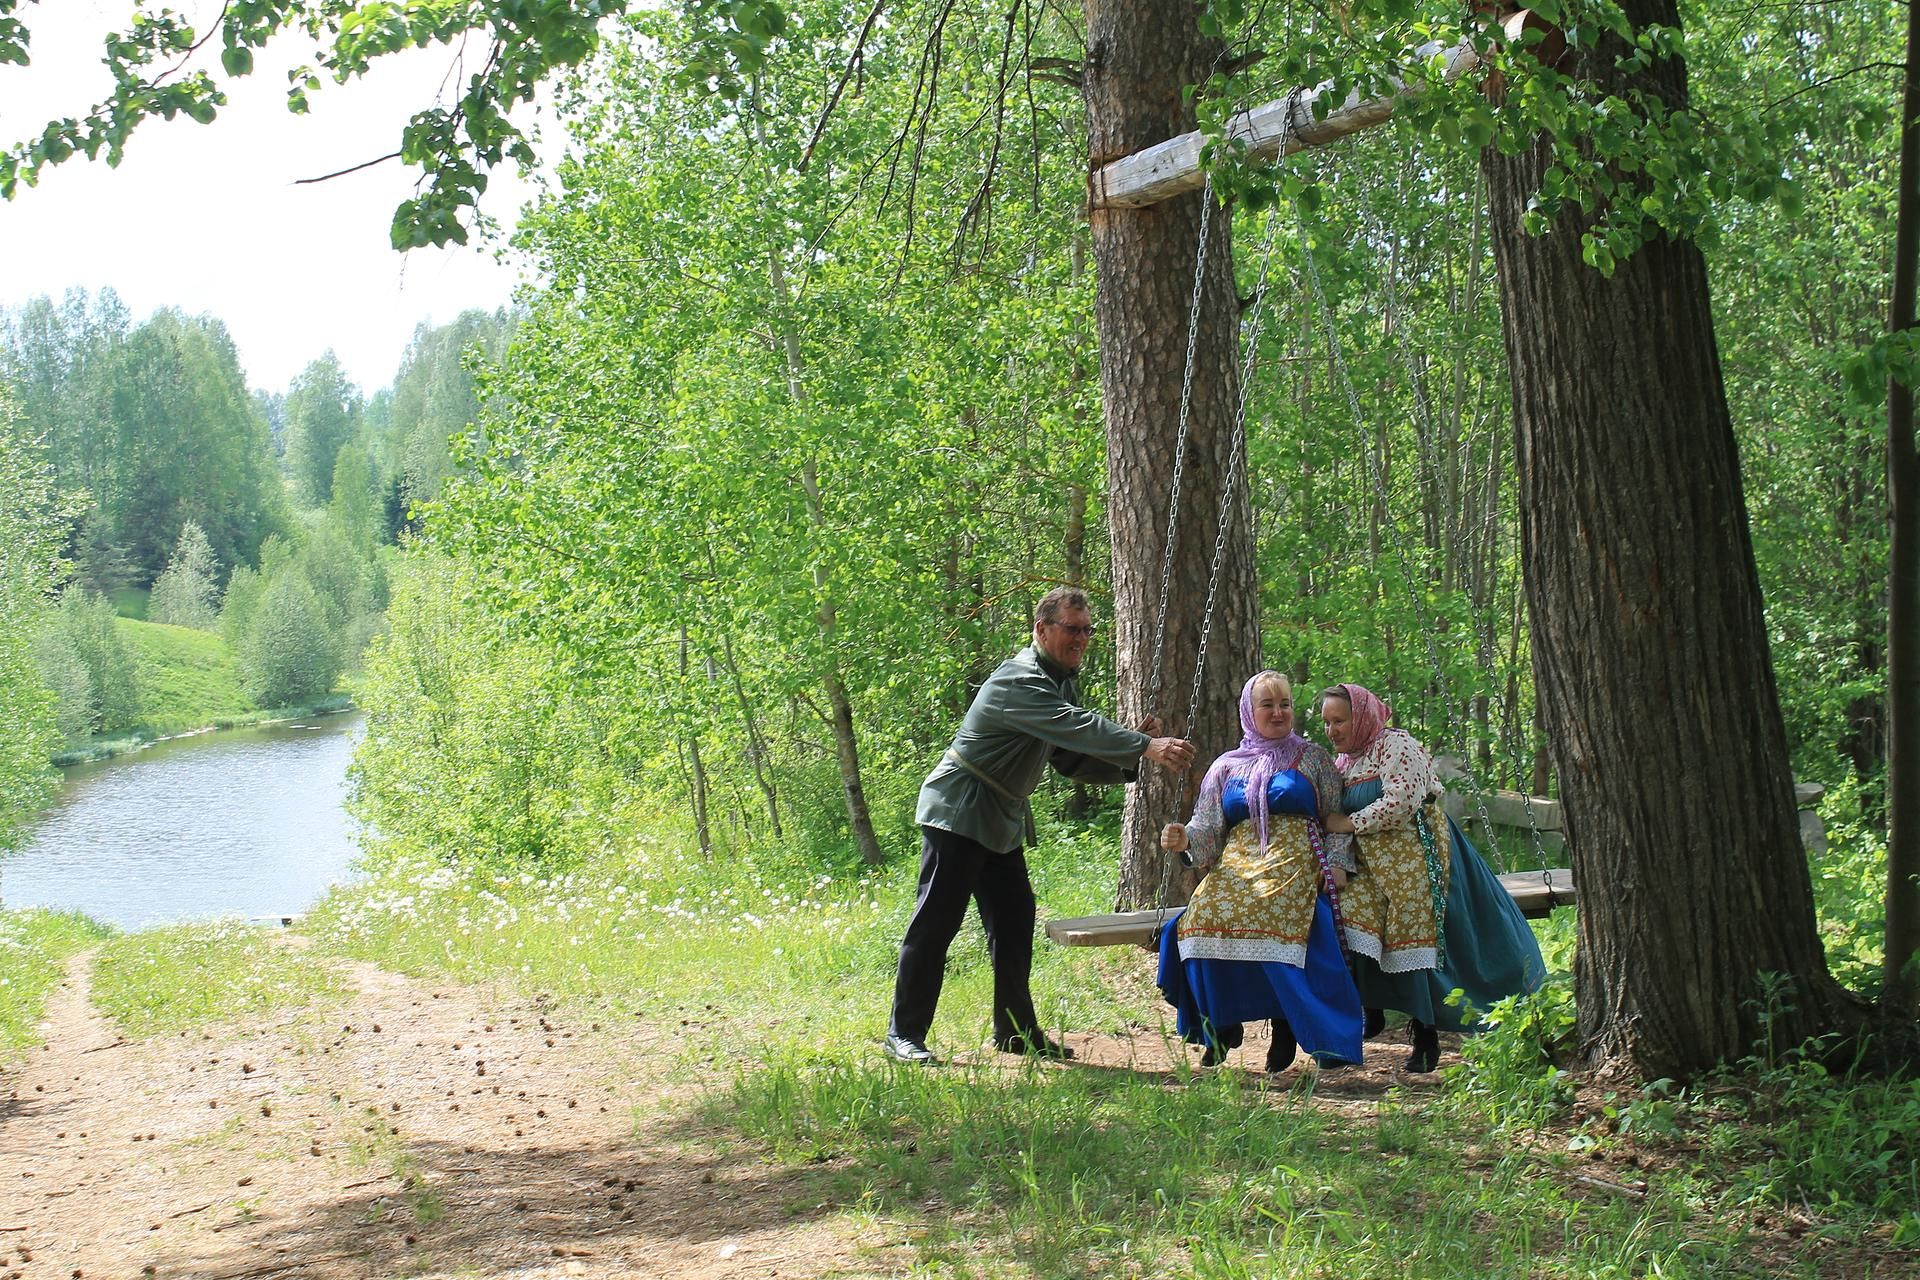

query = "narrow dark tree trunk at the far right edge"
[{"left": 1882, "top": 4, "right": 1920, "bottom": 1017}]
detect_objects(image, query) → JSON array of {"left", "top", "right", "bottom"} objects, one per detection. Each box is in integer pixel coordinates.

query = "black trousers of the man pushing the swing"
[{"left": 889, "top": 827, "right": 1041, "bottom": 1044}]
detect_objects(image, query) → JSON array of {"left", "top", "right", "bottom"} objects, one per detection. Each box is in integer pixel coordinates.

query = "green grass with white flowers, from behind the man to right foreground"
[{"left": 295, "top": 833, "right": 1920, "bottom": 1280}]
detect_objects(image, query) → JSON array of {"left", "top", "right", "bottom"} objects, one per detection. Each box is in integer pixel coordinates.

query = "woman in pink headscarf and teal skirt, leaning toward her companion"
[{"left": 1319, "top": 685, "right": 1546, "bottom": 1071}]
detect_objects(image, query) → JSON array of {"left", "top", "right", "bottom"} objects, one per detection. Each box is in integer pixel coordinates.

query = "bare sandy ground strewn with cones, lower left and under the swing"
[{"left": 0, "top": 938, "right": 1452, "bottom": 1280}]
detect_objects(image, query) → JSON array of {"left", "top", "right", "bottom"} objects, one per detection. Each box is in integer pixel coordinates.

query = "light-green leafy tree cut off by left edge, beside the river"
[{"left": 0, "top": 386, "right": 71, "bottom": 854}]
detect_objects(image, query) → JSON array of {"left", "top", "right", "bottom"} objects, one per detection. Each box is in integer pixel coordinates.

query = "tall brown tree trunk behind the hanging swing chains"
[{"left": 1085, "top": 0, "right": 1260, "bottom": 908}]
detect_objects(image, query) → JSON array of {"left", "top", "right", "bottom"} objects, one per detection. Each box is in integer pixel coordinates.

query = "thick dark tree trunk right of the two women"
[{"left": 1482, "top": 0, "right": 1859, "bottom": 1079}]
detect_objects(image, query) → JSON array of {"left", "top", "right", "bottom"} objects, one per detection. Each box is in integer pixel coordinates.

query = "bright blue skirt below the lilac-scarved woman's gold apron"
[{"left": 1158, "top": 898, "right": 1361, "bottom": 1063}]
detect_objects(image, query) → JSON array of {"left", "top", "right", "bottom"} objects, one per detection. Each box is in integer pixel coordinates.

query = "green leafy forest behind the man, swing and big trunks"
[{"left": 0, "top": 4, "right": 1901, "bottom": 1020}]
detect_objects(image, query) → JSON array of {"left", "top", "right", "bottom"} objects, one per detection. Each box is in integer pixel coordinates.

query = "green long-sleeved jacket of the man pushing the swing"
[{"left": 914, "top": 645, "right": 1152, "bottom": 854}]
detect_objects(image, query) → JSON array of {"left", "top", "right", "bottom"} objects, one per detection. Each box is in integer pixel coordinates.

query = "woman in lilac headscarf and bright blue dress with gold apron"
[{"left": 1160, "top": 672, "right": 1361, "bottom": 1071}]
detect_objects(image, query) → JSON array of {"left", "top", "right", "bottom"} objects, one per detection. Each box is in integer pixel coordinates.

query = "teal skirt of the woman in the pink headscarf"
[{"left": 1354, "top": 818, "right": 1548, "bottom": 1031}]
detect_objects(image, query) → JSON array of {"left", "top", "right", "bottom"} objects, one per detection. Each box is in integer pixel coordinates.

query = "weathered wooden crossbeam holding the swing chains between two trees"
[{"left": 1092, "top": 40, "right": 1480, "bottom": 209}]
